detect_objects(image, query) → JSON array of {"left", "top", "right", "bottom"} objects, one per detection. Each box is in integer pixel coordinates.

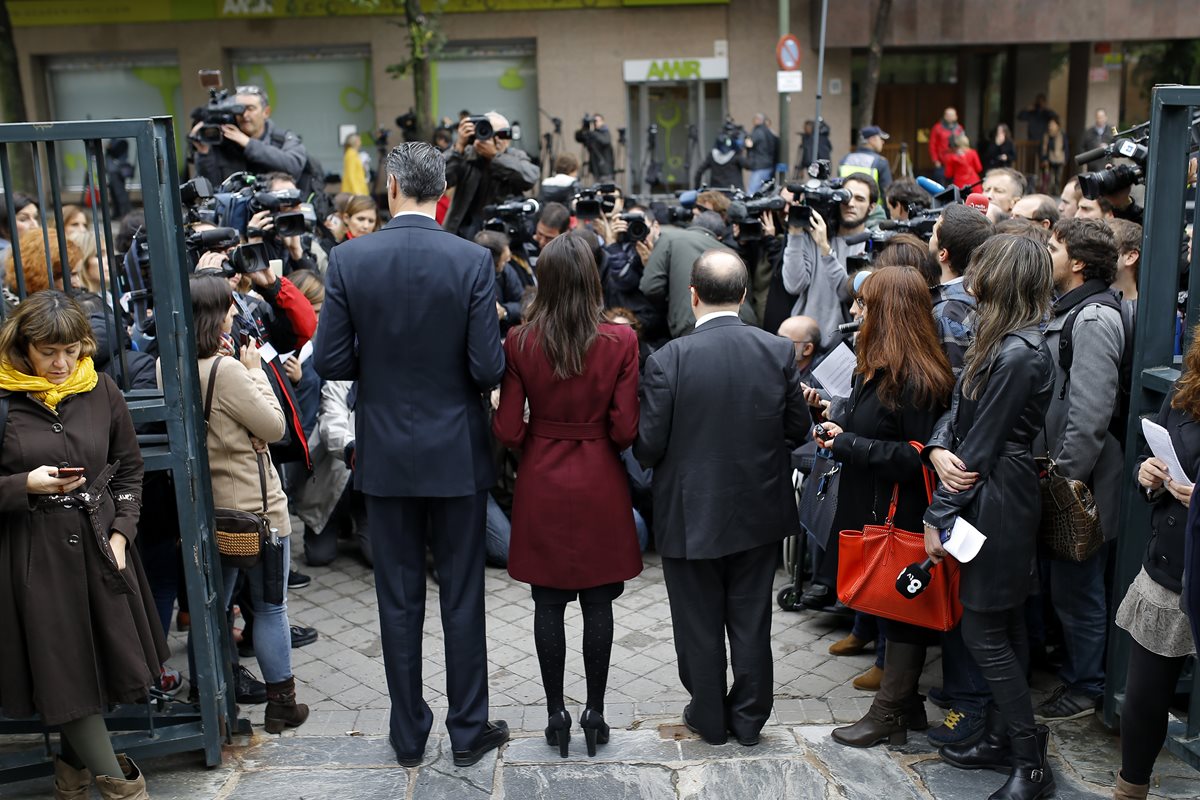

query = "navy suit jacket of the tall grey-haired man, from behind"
[{"left": 313, "top": 215, "right": 504, "bottom": 498}]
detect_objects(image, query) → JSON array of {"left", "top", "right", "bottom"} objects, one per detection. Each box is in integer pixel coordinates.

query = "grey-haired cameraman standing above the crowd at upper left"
[{"left": 187, "top": 78, "right": 307, "bottom": 192}]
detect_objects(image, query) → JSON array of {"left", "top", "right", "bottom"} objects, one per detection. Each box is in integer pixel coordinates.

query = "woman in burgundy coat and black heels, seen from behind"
[{"left": 492, "top": 235, "right": 642, "bottom": 758}]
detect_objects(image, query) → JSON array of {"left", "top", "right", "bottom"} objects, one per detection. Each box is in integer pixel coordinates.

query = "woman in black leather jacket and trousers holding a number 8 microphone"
[{"left": 924, "top": 234, "right": 1055, "bottom": 800}]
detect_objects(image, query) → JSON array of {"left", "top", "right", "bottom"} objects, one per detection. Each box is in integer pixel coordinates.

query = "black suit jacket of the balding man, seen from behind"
[{"left": 634, "top": 317, "right": 812, "bottom": 559}]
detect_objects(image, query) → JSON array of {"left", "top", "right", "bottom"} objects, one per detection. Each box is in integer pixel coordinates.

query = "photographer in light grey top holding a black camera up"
[{"left": 781, "top": 170, "right": 880, "bottom": 350}]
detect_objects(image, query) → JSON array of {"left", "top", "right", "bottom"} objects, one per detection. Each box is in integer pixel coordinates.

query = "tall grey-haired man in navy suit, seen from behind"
[{"left": 313, "top": 142, "right": 509, "bottom": 766}]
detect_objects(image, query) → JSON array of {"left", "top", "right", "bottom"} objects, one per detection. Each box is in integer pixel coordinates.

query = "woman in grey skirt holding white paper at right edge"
[{"left": 1112, "top": 332, "right": 1200, "bottom": 800}]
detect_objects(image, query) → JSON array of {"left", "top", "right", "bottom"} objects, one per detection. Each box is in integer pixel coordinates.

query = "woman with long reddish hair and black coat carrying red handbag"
[{"left": 817, "top": 266, "right": 954, "bottom": 747}]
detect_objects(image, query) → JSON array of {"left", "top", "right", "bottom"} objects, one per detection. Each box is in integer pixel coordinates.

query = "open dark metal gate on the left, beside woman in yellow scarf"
[{"left": 0, "top": 118, "right": 241, "bottom": 783}]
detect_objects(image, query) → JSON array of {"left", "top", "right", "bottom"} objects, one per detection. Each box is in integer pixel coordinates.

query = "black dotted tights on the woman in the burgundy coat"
[{"left": 533, "top": 584, "right": 622, "bottom": 714}]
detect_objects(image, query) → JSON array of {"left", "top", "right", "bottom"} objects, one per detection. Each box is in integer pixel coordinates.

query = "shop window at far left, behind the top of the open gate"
[{"left": 47, "top": 54, "right": 186, "bottom": 189}]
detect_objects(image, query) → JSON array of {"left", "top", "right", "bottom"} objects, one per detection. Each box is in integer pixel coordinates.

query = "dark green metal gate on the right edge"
[{"left": 1104, "top": 86, "right": 1200, "bottom": 769}]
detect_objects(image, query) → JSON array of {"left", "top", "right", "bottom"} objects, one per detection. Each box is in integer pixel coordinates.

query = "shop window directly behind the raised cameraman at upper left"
[{"left": 226, "top": 50, "right": 376, "bottom": 174}]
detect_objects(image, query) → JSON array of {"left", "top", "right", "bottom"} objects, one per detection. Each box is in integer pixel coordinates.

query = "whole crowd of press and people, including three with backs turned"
[{"left": 0, "top": 77, "right": 1200, "bottom": 800}]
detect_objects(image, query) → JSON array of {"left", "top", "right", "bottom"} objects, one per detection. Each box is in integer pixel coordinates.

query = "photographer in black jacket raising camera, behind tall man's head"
[{"left": 442, "top": 112, "right": 541, "bottom": 239}]
